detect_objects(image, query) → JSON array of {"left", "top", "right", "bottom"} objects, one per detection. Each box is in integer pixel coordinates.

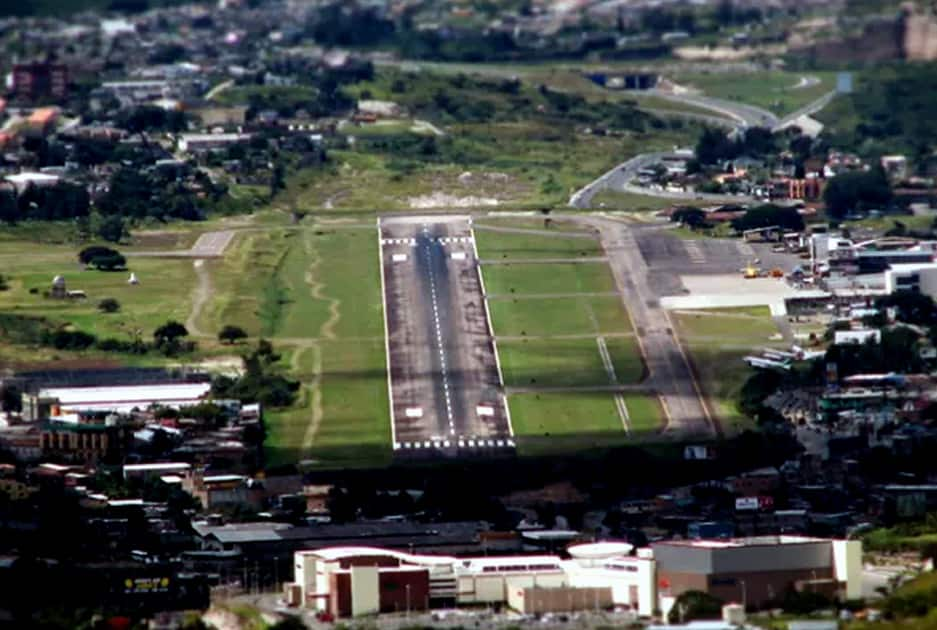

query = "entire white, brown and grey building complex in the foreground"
[{"left": 286, "top": 536, "right": 862, "bottom": 617}]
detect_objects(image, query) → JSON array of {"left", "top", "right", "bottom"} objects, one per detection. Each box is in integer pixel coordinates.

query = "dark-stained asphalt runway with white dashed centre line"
[{"left": 380, "top": 216, "right": 514, "bottom": 456}]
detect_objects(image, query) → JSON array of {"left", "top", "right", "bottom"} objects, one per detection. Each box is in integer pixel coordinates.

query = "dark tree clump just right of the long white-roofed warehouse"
[{"left": 212, "top": 339, "right": 299, "bottom": 407}]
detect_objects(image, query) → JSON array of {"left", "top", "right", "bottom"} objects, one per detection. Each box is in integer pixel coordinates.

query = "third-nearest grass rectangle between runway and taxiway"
[{"left": 486, "top": 298, "right": 632, "bottom": 337}]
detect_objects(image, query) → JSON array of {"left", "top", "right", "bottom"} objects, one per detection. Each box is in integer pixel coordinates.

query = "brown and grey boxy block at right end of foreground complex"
[{"left": 652, "top": 536, "right": 862, "bottom": 607}]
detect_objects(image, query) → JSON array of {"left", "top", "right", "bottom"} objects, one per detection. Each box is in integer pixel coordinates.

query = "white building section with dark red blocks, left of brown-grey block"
[{"left": 287, "top": 543, "right": 657, "bottom": 616}]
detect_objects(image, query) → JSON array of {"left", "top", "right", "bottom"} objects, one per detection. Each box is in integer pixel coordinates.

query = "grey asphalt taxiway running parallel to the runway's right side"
[{"left": 578, "top": 217, "right": 716, "bottom": 436}]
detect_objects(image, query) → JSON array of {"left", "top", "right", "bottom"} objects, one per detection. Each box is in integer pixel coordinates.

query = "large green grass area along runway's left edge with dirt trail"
[{"left": 204, "top": 228, "right": 391, "bottom": 468}]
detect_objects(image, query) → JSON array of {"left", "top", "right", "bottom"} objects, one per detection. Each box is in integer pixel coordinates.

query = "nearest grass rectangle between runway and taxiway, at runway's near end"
[{"left": 508, "top": 392, "right": 662, "bottom": 456}]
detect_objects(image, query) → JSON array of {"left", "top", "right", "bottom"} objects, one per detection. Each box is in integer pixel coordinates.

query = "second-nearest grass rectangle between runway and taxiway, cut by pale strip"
[{"left": 498, "top": 337, "right": 644, "bottom": 387}]
